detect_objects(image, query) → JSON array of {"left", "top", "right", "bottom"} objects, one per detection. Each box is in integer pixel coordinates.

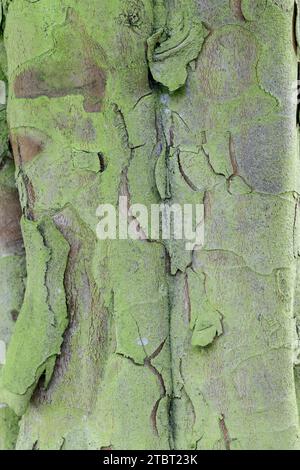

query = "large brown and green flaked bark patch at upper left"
[{"left": 14, "top": 8, "right": 107, "bottom": 113}]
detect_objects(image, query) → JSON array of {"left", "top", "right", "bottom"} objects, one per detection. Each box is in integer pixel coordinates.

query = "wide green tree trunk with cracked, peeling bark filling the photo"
[{"left": 0, "top": 0, "right": 300, "bottom": 450}]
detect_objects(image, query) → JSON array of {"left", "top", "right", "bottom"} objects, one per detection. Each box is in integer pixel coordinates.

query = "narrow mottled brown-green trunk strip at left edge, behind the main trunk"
[{"left": 0, "top": 4, "right": 26, "bottom": 450}]
